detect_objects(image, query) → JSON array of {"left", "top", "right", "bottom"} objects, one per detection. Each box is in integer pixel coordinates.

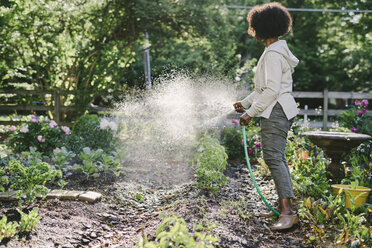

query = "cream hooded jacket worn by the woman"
[{"left": 241, "top": 40, "right": 298, "bottom": 120}]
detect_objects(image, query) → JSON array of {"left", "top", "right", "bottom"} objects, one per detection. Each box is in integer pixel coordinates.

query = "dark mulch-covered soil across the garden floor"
[{"left": 0, "top": 161, "right": 311, "bottom": 248}]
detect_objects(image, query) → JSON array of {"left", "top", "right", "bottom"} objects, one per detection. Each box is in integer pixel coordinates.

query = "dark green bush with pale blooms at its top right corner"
[{"left": 66, "top": 115, "right": 117, "bottom": 154}]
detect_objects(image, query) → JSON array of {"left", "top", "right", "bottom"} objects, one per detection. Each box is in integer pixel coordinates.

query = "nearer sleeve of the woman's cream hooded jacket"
[{"left": 246, "top": 52, "right": 282, "bottom": 117}]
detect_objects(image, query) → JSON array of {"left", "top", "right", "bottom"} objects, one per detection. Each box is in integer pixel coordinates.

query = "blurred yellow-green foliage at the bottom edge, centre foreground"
[{"left": 136, "top": 217, "right": 219, "bottom": 248}]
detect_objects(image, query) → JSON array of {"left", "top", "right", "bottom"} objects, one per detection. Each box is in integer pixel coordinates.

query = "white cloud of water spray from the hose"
[{"left": 115, "top": 75, "right": 243, "bottom": 186}]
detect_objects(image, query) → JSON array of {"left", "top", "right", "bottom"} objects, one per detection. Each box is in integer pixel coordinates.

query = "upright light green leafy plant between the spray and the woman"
[{"left": 191, "top": 135, "right": 228, "bottom": 192}]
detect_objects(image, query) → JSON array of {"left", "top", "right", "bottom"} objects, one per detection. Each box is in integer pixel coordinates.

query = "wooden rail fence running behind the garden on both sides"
[{"left": 0, "top": 89, "right": 372, "bottom": 130}]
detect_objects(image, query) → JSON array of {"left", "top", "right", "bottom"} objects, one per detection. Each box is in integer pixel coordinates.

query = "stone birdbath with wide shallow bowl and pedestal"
[{"left": 301, "top": 131, "right": 372, "bottom": 183}]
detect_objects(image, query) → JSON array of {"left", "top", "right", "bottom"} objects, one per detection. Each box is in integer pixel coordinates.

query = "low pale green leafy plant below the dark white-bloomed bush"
[{"left": 77, "top": 147, "right": 120, "bottom": 179}]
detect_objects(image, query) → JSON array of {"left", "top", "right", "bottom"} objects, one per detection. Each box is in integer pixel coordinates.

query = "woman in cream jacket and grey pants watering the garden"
[{"left": 234, "top": 2, "right": 298, "bottom": 230}]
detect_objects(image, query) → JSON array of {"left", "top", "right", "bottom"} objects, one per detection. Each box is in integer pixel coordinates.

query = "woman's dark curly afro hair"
[{"left": 247, "top": 2, "right": 292, "bottom": 41}]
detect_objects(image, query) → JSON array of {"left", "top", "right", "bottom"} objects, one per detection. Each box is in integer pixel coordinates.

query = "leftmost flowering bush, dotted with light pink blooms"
[{"left": 7, "top": 115, "right": 70, "bottom": 155}]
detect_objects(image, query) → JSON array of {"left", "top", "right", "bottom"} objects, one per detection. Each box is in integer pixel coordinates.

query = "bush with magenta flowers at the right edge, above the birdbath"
[{"left": 339, "top": 100, "right": 372, "bottom": 134}]
